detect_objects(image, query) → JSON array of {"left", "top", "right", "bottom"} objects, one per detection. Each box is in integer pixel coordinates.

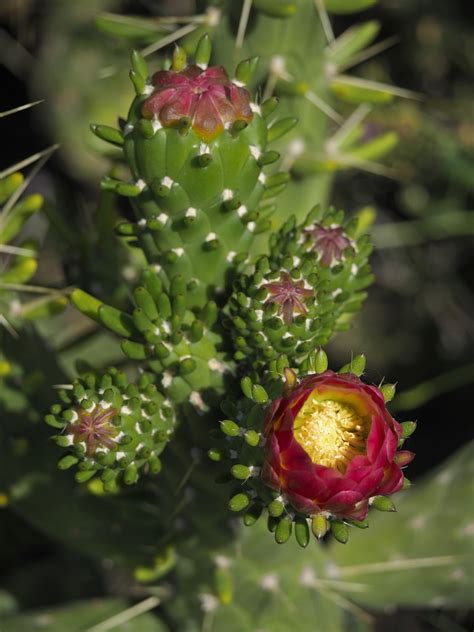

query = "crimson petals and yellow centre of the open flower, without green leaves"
[{"left": 262, "top": 371, "right": 414, "bottom": 520}]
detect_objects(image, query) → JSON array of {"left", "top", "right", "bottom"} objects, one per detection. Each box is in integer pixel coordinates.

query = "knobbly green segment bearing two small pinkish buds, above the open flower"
[{"left": 227, "top": 202, "right": 372, "bottom": 370}]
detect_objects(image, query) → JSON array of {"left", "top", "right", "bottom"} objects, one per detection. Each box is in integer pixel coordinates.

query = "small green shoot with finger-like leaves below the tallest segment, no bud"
[{"left": 71, "top": 267, "right": 224, "bottom": 404}]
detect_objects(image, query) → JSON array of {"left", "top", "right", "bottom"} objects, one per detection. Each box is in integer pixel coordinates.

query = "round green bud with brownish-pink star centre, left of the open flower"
[{"left": 45, "top": 368, "right": 176, "bottom": 492}]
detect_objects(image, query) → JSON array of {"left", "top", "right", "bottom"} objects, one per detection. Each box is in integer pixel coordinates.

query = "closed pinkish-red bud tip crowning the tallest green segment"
[{"left": 142, "top": 65, "right": 253, "bottom": 142}]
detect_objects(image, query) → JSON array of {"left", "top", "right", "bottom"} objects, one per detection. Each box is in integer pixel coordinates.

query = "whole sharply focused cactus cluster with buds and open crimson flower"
[{"left": 46, "top": 13, "right": 409, "bottom": 546}]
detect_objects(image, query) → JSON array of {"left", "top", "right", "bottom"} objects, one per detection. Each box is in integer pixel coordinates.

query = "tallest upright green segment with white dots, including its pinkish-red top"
[{"left": 94, "top": 36, "right": 296, "bottom": 307}]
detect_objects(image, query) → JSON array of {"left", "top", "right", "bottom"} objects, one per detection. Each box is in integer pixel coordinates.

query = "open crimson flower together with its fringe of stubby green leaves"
[{"left": 211, "top": 352, "right": 414, "bottom": 546}]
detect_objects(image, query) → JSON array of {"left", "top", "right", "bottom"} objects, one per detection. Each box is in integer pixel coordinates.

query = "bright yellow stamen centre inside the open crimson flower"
[{"left": 293, "top": 392, "right": 370, "bottom": 473}]
